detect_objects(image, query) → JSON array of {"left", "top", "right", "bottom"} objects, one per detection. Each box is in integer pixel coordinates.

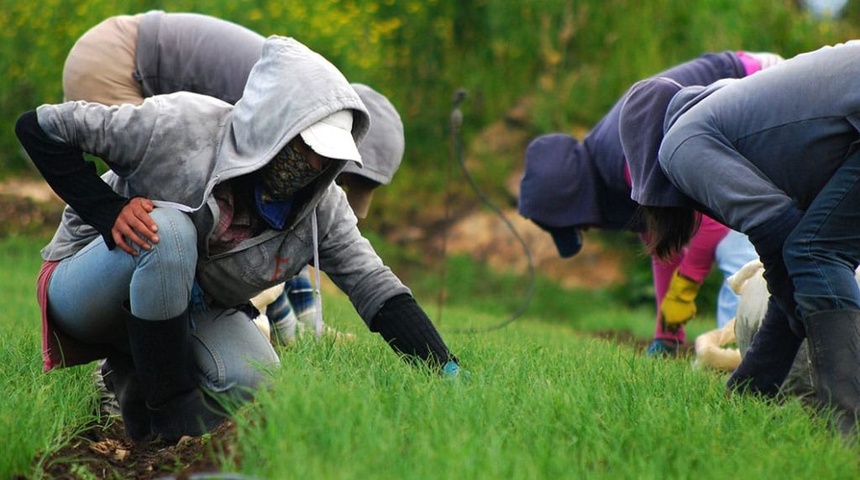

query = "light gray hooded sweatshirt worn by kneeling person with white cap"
[{"left": 37, "top": 36, "right": 411, "bottom": 322}]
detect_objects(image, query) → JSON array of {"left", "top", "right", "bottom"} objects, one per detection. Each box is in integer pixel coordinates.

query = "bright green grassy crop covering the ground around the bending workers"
[{"left": 0, "top": 237, "right": 860, "bottom": 479}]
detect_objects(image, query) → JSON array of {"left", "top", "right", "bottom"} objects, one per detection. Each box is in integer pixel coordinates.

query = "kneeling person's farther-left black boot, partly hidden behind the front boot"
[{"left": 101, "top": 354, "right": 152, "bottom": 442}]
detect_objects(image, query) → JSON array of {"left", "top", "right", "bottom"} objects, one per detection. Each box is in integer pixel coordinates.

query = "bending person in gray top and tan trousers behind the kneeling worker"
[{"left": 63, "top": 10, "right": 405, "bottom": 343}]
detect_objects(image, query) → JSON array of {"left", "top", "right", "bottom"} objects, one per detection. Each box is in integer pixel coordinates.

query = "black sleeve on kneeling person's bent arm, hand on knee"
[{"left": 15, "top": 110, "right": 129, "bottom": 249}]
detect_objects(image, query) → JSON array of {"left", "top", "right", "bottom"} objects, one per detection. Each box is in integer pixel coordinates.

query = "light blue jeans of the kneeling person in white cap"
[{"left": 48, "top": 208, "right": 279, "bottom": 392}]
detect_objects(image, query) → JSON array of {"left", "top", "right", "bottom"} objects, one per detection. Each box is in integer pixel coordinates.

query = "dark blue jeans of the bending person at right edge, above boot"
[{"left": 783, "top": 152, "right": 860, "bottom": 318}]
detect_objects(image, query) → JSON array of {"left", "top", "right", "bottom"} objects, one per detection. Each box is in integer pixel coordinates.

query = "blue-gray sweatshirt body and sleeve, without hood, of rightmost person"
[{"left": 660, "top": 40, "right": 860, "bottom": 233}]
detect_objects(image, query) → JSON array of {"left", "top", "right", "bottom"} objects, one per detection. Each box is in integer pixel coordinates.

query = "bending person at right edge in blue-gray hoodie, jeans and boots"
[{"left": 619, "top": 40, "right": 860, "bottom": 440}]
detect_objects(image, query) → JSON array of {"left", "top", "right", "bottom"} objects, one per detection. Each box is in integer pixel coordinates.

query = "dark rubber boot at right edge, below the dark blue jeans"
[{"left": 804, "top": 310, "right": 860, "bottom": 438}]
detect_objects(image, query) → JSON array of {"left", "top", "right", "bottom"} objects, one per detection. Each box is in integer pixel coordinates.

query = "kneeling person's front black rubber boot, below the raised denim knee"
[{"left": 126, "top": 312, "right": 226, "bottom": 442}]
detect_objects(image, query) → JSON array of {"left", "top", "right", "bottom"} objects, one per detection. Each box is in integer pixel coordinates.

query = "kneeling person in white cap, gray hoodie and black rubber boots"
[{"left": 16, "top": 36, "right": 459, "bottom": 440}]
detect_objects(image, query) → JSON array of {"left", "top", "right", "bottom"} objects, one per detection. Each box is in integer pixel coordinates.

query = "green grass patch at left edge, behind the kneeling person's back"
[{"left": 0, "top": 237, "right": 95, "bottom": 478}]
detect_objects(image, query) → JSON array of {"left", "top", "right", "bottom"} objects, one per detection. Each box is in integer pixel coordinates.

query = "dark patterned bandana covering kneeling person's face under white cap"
[{"left": 260, "top": 142, "right": 322, "bottom": 202}]
